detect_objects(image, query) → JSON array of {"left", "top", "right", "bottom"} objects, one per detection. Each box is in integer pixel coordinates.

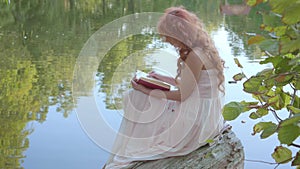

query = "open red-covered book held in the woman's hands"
[{"left": 135, "top": 70, "right": 171, "bottom": 90}]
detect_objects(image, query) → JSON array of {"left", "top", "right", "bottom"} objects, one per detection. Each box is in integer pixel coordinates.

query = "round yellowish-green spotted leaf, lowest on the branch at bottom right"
[{"left": 272, "top": 146, "right": 292, "bottom": 164}]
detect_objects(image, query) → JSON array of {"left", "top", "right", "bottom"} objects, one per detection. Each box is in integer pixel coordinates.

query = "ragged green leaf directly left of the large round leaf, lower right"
[{"left": 253, "top": 122, "right": 277, "bottom": 138}]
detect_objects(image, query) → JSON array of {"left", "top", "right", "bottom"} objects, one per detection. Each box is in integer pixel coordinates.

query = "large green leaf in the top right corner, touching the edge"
[{"left": 282, "top": 3, "right": 300, "bottom": 25}]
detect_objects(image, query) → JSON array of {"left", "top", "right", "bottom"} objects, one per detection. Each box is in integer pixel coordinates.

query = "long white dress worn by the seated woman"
[{"left": 105, "top": 69, "right": 224, "bottom": 169}]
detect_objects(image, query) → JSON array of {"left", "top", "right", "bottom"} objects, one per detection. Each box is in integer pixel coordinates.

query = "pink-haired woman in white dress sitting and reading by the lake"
[{"left": 105, "top": 7, "right": 224, "bottom": 169}]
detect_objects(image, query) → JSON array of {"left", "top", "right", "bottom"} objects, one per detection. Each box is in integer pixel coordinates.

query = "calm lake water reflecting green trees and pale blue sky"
[{"left": 0, "top": 0, "right": 296, "bottom": 169}]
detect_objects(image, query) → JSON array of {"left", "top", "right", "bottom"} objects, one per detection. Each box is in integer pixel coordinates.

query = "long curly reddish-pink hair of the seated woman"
[{"left": 157, "top": 6, "right": 225, "bottom": 93}]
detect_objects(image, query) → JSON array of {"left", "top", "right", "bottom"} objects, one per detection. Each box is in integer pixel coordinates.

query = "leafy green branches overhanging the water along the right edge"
[{"left": 223, "top": 0, "right": 300, "bottom": 166}]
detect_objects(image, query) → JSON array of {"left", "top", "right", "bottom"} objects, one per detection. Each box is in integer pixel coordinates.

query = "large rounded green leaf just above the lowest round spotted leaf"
[{"left": 278, "top": 124, "right": 300, "bottom": 145}]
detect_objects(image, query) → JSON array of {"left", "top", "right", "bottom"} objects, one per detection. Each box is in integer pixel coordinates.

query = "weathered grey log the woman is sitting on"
[{"left": 124, "top": 129, "right": 245, "bottom": 169}]
